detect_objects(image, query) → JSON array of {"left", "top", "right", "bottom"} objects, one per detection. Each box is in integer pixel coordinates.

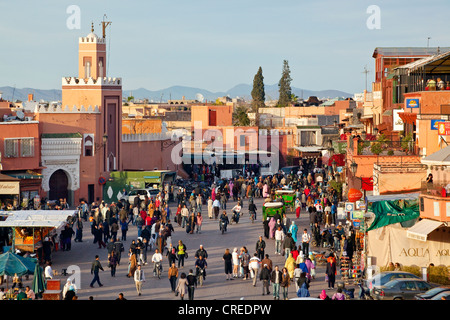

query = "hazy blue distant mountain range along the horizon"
[{"left": 0, "top": 84, "right": 353, "bottom": 102}]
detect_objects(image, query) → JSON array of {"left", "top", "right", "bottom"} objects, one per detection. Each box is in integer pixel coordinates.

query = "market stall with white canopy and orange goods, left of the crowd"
[{"left": 0, "top": 210, "right": 76, "bottom": 258}]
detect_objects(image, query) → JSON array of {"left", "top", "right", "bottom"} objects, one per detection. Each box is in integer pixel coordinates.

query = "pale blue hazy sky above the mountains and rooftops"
[{"left": 0, "top": 0, "right": 450, "bottom": 93}]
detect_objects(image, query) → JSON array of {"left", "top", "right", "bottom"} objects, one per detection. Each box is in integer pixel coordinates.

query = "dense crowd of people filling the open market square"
[{"left": 0, "top": 159, "right": 364, "bottom": 299}]
